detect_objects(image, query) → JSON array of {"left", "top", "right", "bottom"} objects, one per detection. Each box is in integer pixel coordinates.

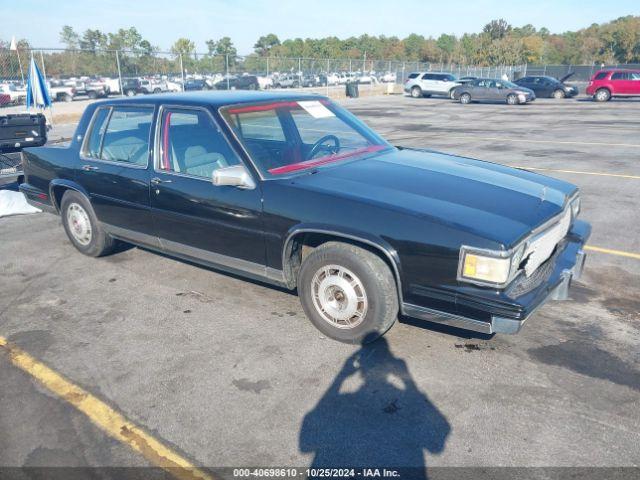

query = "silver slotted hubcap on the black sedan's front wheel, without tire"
[{"left": 311, "top": 265, "right": 368, "bottom": 329}]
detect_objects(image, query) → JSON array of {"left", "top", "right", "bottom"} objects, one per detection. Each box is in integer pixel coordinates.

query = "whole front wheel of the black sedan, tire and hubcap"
[{"left": 298, "top": 242, "right": 398, "bottom": 344}]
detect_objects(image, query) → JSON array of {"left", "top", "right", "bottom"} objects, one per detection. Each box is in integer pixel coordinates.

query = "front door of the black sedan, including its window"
[{"left": 151, "top": 106, "right": 266, "bottom": 277}]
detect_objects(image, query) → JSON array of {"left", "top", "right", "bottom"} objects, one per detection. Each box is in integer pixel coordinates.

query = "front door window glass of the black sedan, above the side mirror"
[{"left": 156, "top": 108, "right": 239, "bottom": 179}]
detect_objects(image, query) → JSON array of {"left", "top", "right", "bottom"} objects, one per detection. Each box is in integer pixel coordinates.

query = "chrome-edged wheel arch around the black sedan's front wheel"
[{"left": 282, "top": 225, "right": 402, "bottom": 305}]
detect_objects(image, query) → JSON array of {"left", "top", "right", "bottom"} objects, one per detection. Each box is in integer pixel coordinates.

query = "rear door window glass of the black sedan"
[{"left": 83, "top": 107, "right": 153, "bottom": 167}]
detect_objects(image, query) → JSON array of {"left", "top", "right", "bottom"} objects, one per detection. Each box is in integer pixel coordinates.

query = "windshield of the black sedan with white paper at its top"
[{"left": 221, "top": 99, "right": 393, "bottom": 178}]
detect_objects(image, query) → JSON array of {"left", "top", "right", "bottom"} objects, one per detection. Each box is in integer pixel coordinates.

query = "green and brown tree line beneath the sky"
[{"left": 0, "top": 15, "right": 640, "bottom": 75}]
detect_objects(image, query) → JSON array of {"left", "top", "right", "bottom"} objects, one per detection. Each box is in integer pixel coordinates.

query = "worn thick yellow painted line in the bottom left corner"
[{"left": 0, "top": 336, "right": 213, "bottom": 480}]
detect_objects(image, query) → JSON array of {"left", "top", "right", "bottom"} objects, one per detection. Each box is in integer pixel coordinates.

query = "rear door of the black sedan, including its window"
[{"left": 76, "top": 106, "right": 157, "bottom": 246}]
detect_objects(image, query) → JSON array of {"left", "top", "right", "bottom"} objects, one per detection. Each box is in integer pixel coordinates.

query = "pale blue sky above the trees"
[{"left": 6, "top": 0, "right": 640, "bottom": 54}]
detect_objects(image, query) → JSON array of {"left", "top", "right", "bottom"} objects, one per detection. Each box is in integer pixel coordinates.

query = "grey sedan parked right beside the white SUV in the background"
[{"left": 452, "top": 78, "right": 536, "bottom": 105}]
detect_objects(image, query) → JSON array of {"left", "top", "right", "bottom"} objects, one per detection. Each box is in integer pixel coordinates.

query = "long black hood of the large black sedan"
[{"left": 291, "top": 149, "right": 576, "bottom": 248}]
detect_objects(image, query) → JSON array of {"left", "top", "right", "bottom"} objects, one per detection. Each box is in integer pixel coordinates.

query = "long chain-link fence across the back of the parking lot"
[{"left": 0, "top": 48, "right": 640, "bottom": 104}]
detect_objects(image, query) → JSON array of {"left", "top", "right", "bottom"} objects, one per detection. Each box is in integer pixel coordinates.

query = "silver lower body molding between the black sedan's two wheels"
[{"left": 102, "top": 223, "right": 286, "bottom": 287}]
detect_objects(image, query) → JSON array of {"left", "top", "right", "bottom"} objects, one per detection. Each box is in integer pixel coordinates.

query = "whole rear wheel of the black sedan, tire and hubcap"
[{"left": 60, "top": 190, "right": 115, "bottom": 257}]
